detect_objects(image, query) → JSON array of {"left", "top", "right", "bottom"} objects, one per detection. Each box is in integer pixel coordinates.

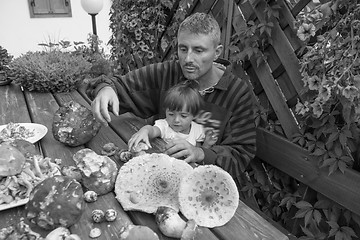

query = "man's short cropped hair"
[{"left": 178, "top": 12, "right": 221, "bottom": 46}]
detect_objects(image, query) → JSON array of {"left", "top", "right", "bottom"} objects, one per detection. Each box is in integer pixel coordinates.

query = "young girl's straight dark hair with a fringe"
[{"left": 163, "top": 80, "right": 202, "bottom": 116}]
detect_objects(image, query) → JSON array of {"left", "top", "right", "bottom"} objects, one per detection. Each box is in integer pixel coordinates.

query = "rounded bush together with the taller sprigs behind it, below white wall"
[{"left": 9, "top": 34, "right": 113, "bottom": 92}]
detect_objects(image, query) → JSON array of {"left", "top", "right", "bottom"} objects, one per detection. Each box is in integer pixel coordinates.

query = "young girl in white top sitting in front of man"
[{"left": 128, "top": 81, "right": 217, "bottom": 150}]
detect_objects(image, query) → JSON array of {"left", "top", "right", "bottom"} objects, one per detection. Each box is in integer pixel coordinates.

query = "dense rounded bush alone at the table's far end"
[{"left": 10, "top": 50, "right": 91, "bottom": 92}]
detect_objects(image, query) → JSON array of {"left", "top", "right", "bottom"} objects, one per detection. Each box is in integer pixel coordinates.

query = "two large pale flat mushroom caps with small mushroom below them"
[{"left": 114, "top": 153, "right": 239, "bottom": 240}]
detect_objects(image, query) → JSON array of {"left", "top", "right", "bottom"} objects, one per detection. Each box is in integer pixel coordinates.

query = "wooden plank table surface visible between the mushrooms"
[{"left": 0, "top": 84, "right": 288, "bottom": 240}]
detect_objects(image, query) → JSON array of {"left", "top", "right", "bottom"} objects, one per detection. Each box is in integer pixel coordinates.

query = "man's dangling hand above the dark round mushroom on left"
[{"left": 91, "top": 87, "right": 119, "bottom": 126}]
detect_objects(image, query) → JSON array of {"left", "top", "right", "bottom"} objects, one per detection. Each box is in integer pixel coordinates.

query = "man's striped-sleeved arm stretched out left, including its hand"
[{"left": 86, "top": 61, "right": 181, "bottom": 120}]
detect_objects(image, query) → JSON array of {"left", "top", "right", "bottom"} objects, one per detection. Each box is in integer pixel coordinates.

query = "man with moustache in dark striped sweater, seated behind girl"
[{"left": 87, "top": 13, "right": 256, "bottom": 178}]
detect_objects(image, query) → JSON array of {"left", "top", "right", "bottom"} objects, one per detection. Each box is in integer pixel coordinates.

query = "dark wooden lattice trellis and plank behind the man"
[{"left": 117, "top": 0, "right": 360, "bottom": 224}]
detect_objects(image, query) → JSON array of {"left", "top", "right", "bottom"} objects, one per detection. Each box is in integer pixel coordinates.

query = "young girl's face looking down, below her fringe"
[{"left": 166, "top": 107, "right": 194, "bottom": 134}]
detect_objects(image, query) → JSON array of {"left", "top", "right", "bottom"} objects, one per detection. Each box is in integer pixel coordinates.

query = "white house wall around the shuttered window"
[{"left": 0, "top": 0, "right": 112, "bottom": 57}]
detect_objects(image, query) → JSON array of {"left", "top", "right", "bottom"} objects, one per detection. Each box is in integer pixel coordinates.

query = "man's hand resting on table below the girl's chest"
[{"left": 165, "top": 139, "right": 205, "bottom": 163}]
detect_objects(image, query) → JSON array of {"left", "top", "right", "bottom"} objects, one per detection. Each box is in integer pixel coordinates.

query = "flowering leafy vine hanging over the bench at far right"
[{"left": 294, "top": 0, "right": 360, "bottom": 174}]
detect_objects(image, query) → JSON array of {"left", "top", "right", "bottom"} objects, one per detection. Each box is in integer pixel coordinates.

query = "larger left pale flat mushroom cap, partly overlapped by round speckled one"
[{"left": 115, "top": 153, "right": 193, "bottom": 213}]
